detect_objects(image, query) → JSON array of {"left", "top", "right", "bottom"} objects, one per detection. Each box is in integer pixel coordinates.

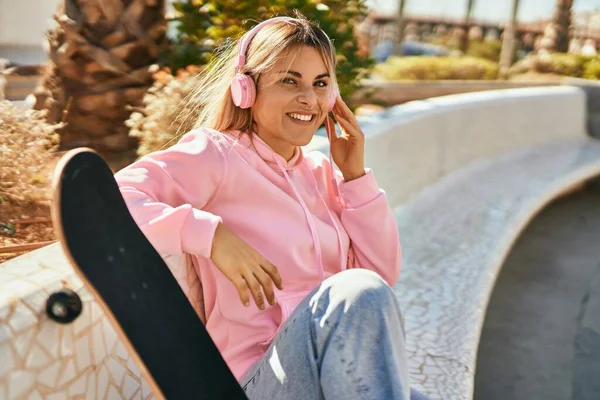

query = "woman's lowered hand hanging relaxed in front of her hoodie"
[{"left": 210, "top": 223, "right": 283, "bottom": 310}]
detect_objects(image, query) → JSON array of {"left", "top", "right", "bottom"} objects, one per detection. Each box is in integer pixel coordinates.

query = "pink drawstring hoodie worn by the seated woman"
[{"left": 115, "top": 129, "right": 401, "bottom": 380}]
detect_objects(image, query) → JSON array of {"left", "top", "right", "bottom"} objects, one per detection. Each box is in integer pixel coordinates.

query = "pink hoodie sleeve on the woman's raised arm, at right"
[{"left": 330, "top": 166, "right": 402, "bottom": 286}]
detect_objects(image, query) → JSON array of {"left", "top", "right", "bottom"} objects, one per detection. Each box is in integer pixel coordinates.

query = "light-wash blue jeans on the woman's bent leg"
[{"left": 241, "top": 269, "right": 424, "bottom": 400}]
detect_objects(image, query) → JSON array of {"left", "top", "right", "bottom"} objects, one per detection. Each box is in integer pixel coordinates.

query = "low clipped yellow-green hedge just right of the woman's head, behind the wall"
[{"left": 373, "top": 57, "right": 498, "bottom": 81}]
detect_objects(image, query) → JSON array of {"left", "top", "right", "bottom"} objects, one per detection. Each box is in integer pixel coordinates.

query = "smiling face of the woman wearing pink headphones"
[{"left": 252, "top": 46, "right": 333, "bottom": 160}]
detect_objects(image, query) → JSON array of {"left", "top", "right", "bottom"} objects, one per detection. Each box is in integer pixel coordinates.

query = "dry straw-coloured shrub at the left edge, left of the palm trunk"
[{"left": 0, "top": 100, "right": 60, "bottom": 203}]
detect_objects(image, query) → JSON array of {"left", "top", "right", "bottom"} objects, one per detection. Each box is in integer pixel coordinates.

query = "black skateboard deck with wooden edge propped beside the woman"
[{"left": 52, "top": 148, "right": 247, "bottom": 400}]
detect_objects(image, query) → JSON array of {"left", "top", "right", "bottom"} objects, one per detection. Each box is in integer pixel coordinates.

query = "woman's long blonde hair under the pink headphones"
[{"left": 186, "top": 15, "right": 337, "bottom": 133}]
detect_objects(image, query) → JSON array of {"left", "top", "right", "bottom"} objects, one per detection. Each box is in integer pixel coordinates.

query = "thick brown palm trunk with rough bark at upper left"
[{"left": 36, "top": 0, "right": 166, "bottom": 153}]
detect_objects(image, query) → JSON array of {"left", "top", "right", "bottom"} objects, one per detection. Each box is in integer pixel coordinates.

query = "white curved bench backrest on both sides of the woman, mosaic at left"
[{"left": 0, "top": 87, "right": 586, "bottom": 399}]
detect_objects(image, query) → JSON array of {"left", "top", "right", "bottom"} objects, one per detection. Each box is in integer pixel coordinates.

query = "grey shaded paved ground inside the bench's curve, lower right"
[{"left": 474, "top": 184, "right": 600, "bottom": 400}]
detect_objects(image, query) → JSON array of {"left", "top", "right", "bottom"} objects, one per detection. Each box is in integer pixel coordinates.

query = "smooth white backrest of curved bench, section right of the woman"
[{"left": 361, "top": 87, "right": 586, "bottom": 206}]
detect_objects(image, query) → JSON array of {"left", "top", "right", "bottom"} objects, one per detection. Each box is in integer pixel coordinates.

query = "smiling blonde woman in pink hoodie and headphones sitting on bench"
[{"left": 116, "top": 17, "right": 424, "bottom": 400}]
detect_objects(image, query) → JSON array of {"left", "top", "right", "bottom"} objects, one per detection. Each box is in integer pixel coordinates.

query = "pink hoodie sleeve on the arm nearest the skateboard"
[{"left": 115, "top": 130, "right": 226, "bottom": 258}]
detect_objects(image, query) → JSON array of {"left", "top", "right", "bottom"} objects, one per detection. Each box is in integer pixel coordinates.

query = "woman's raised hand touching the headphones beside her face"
[{"left": 326, "top": 96, "right": 365, "bottom": 182}]
